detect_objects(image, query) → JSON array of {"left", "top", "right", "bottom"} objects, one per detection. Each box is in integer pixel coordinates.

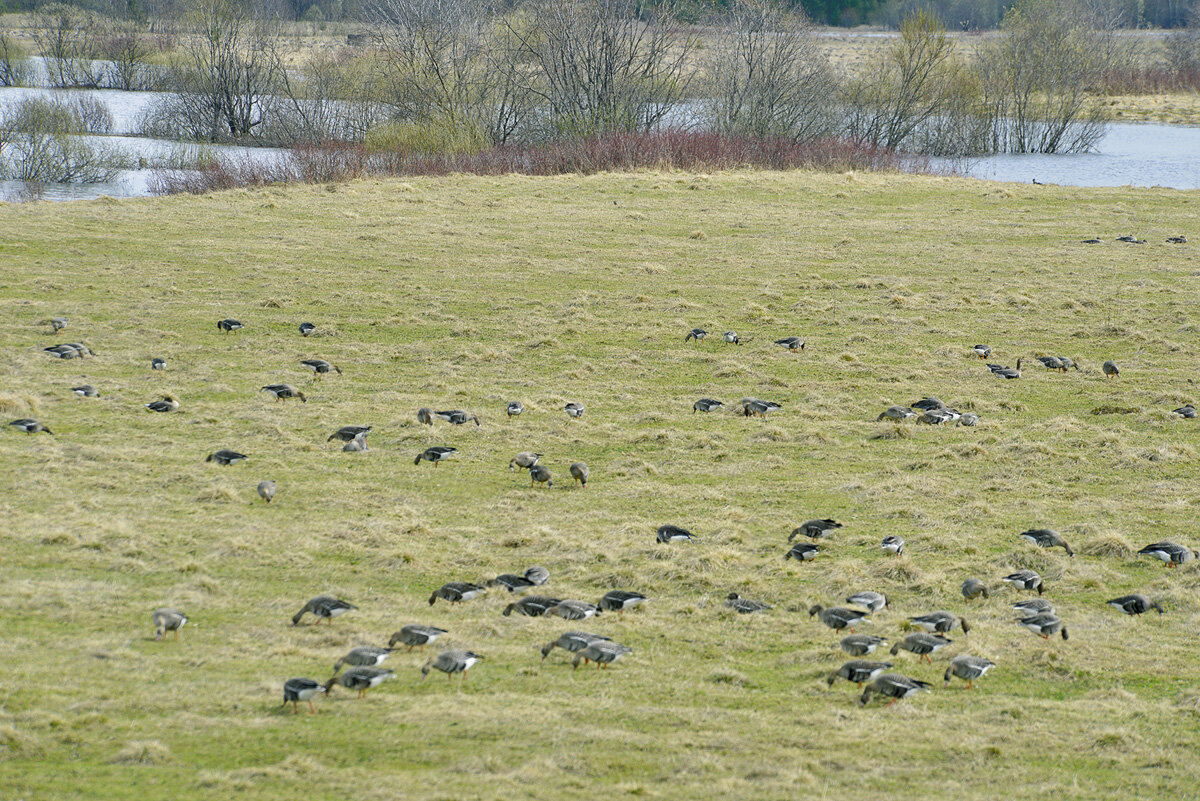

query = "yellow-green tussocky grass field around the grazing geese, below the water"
[{"left": 0, "top": 173, "right": 1200, "bottom": 801}]
